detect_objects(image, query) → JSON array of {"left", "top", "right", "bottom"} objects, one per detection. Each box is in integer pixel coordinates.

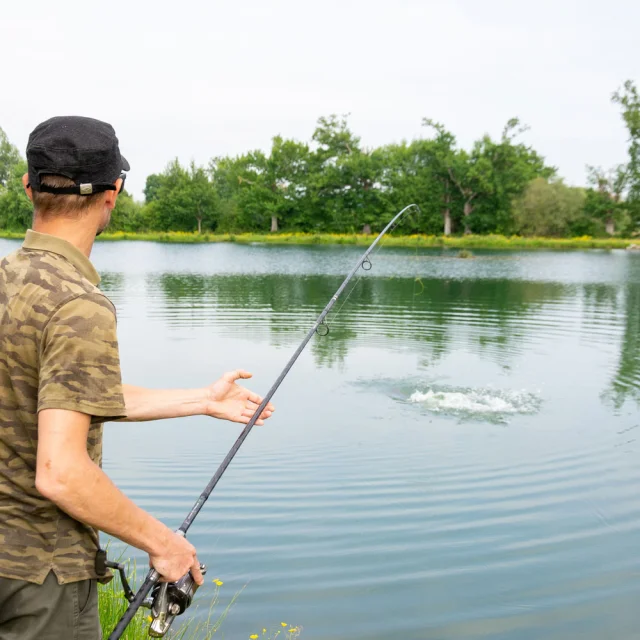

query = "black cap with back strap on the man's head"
[{"left": 27, "top": 116, "right": 129, "bottom": 195}]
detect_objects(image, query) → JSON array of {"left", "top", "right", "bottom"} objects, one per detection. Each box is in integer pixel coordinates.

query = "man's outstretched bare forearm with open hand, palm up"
[{"left": 122, "top": 369, "right": 274, "bottom": 425}]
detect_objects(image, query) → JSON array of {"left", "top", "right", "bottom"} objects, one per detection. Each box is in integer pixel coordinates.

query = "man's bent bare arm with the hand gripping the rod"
[{"left": 36, "top": 409, "right": 202, "bottom": 584}]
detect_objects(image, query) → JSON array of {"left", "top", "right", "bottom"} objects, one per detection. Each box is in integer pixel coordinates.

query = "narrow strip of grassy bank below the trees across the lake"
[{"left": 0, "top": 230, "right": 640, "bottom": 249}]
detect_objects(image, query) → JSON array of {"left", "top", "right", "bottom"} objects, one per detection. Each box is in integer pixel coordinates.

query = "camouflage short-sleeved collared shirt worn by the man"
[{"left": 0, "top": 231, "right": 125, "bottom": 584}]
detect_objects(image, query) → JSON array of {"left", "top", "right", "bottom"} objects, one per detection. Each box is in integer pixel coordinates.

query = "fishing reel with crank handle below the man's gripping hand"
[{"left": 96, "top": 549, "right": 207, "bottom": 638}]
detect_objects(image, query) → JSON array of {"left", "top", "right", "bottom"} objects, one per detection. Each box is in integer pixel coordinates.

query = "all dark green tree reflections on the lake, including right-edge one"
[{"left": 101, "top": 259, "right": 640, "bottom": 409}]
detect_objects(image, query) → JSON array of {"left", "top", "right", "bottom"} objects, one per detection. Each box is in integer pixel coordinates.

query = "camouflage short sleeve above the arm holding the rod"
[{"left": 38, "top": 292, "right": 126, "bottom": 422}]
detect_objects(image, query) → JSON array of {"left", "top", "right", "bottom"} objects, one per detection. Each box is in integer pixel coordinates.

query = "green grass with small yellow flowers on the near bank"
[{"left": 98, "top": 559, "right": 302, "bottom": 640}]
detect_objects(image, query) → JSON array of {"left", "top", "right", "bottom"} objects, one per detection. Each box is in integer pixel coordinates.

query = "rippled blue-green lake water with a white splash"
[{"left": 0, "top": 241, "right": 640, "bottom": 640}]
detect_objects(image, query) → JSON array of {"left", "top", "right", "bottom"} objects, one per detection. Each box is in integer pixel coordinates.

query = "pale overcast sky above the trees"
[{"left": 0, "top": 0, "right": 640, "bottom": 197}]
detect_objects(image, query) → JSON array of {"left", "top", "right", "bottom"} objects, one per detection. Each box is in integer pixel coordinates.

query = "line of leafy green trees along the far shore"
[{"left": 0, "top": 81, "right": 640, "bottom": 237}]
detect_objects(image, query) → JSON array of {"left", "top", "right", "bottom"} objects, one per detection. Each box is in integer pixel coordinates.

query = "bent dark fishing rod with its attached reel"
[{"left": 109, "top": 204, "right": 420, "bottom": 640}]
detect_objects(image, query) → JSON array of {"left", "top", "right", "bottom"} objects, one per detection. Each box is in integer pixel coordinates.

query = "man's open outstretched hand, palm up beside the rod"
[{"left": 205, "top": 369, "right": 275, "bottom": 425}]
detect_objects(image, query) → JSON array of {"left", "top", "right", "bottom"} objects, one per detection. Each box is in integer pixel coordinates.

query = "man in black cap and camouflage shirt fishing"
[{"left": 0, "top": 117, "right": 273, "bottom": 640}]
